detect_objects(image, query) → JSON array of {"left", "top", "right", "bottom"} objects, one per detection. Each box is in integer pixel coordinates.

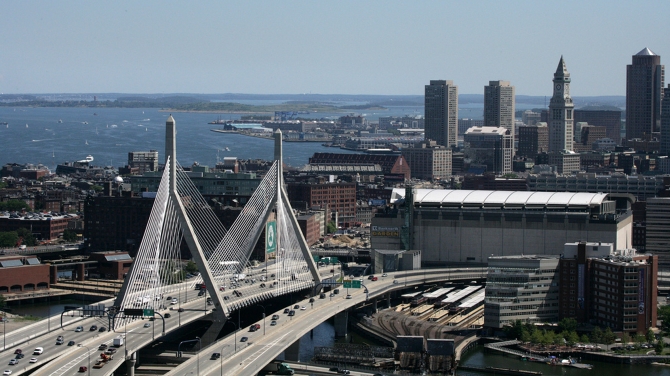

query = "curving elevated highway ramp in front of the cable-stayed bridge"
[{"left": 168, "top": 268, "right": 486, "bottom": 376}]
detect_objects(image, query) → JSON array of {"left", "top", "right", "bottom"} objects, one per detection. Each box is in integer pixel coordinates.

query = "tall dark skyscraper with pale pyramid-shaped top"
[{"left": 626, "top": 48, "right": 665, "bottom": 140}]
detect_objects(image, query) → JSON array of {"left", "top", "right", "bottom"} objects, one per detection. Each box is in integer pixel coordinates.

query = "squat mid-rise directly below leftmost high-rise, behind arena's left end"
[{"left": 402, "top": 140, "right": 451, "bottom": 180}]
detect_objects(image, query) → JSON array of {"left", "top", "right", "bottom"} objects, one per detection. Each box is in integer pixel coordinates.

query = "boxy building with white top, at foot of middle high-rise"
[{"left": 463, "top": 127, "right": 514, "bottom": 175}]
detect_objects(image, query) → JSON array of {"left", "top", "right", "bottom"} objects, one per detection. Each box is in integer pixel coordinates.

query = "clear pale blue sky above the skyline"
[{"left": 0, "top": 0, "right": 670, "bottom": 96}]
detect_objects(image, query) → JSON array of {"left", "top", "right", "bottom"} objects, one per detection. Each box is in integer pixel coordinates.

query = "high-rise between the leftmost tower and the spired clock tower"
[{"left": 484, "top": 81, "right": 514, "bottom": 139}]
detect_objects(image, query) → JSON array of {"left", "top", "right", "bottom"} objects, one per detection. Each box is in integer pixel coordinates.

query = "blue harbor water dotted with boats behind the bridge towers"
[{"left": 0, "top": 107, "right": 362, "bottom": 168}]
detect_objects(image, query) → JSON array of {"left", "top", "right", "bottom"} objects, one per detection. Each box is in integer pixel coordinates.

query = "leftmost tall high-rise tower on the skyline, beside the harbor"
[{"left": 424, "top": 80, "right": 458, "bottom": 147}]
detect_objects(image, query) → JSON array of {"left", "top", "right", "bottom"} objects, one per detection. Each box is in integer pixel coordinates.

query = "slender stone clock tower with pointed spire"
[{"left": 549, "top": 56, "right": 575, "bottom": 152}]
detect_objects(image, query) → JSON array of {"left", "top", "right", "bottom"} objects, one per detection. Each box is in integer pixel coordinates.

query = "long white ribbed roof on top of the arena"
[{"left": 391, "top": 188, "right": 607, "bottom": 207}]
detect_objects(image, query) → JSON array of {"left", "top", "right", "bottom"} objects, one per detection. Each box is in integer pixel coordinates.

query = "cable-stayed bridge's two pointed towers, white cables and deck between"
[{"left": 115, "top": 116, "right": 320, "bottom": 336}]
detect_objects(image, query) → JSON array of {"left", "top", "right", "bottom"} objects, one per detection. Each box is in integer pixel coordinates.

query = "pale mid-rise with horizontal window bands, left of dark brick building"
[{"left": 484, "top": 255, "right": 560, "bottom": 328}]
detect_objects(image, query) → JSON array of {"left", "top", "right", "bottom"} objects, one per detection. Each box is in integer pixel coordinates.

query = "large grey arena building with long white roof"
[{"left": 371, "top": 189, "right": 634, "bottom": 266}]
